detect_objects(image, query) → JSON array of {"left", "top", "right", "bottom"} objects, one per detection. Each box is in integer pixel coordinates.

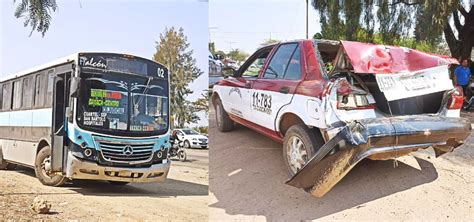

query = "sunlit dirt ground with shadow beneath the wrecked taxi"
[{"left": 209, "top": 107, "right": 474, "bottom": 221}]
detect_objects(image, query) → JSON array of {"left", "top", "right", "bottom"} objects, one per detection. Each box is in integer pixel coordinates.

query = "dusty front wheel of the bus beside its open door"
[{"left": 35, "top": 146, "right": 67, "bottom": 187}]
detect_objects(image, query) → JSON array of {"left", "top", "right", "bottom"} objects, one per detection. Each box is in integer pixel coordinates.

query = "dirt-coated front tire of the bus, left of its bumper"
[{"left": 35, "top": 146, "right": 67, "bottom": 187}]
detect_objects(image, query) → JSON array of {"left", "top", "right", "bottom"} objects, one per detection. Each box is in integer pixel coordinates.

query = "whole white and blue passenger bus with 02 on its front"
[{"left": 0, "top": 53, "right": 170, "bottom": 186}]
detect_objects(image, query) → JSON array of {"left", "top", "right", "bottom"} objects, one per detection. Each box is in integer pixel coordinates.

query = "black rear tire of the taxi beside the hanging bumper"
[{"left": 283, "top": 123, "right": 324, "bottom": 178}]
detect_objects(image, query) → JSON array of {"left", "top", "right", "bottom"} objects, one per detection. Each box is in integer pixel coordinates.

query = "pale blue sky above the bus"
[{"left": 0, "top": 0, "right": 209, "bottom": 125}]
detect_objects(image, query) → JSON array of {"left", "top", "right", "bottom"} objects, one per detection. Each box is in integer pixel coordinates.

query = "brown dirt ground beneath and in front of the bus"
[{"left": 0, "top": 149, "right": 209, "bottom": 221}]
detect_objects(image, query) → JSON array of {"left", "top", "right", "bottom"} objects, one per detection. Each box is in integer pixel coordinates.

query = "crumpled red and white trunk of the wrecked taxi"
[{"left": 317, "top": 41, "right": 457, "bottom": 119}]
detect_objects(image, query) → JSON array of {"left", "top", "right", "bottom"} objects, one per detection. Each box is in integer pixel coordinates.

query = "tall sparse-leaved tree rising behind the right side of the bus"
[{"left": 153, "top": 27, "right": 203, "bottom": 128}]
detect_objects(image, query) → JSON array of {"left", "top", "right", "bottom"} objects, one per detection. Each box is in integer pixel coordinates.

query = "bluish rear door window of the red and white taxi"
[{"left": 263, "top": 43, "right": 299, "bottom": 79}]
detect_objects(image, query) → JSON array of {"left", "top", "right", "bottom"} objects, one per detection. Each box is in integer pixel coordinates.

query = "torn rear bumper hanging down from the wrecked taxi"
[{"left": 286, "top": 115, "right": 471, "bottom": 197}]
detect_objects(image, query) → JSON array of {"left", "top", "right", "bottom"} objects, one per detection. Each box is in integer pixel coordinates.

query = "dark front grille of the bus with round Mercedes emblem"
[{"left": 97, "top": 141, "right": 154, "bottom": 164}]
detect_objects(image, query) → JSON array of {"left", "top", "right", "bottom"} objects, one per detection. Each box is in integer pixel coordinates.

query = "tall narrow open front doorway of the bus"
[{"left": 51, "top": 73, "right": 70, "bottom": 172}]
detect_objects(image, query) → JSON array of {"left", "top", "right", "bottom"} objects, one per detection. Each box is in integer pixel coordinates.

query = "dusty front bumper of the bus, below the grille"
[{"left": 66, "top": 152, "right": 171, "bottom": 183}]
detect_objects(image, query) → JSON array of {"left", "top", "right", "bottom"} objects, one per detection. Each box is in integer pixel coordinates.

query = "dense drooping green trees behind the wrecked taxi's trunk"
[{"left": 312, "top": 0, "right": 474, "bottom": 58}]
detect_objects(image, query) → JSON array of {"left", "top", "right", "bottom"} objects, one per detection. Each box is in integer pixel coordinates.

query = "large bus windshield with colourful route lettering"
[{"left": 77, "top": 72, "right": 169, "bottom": 136}]
